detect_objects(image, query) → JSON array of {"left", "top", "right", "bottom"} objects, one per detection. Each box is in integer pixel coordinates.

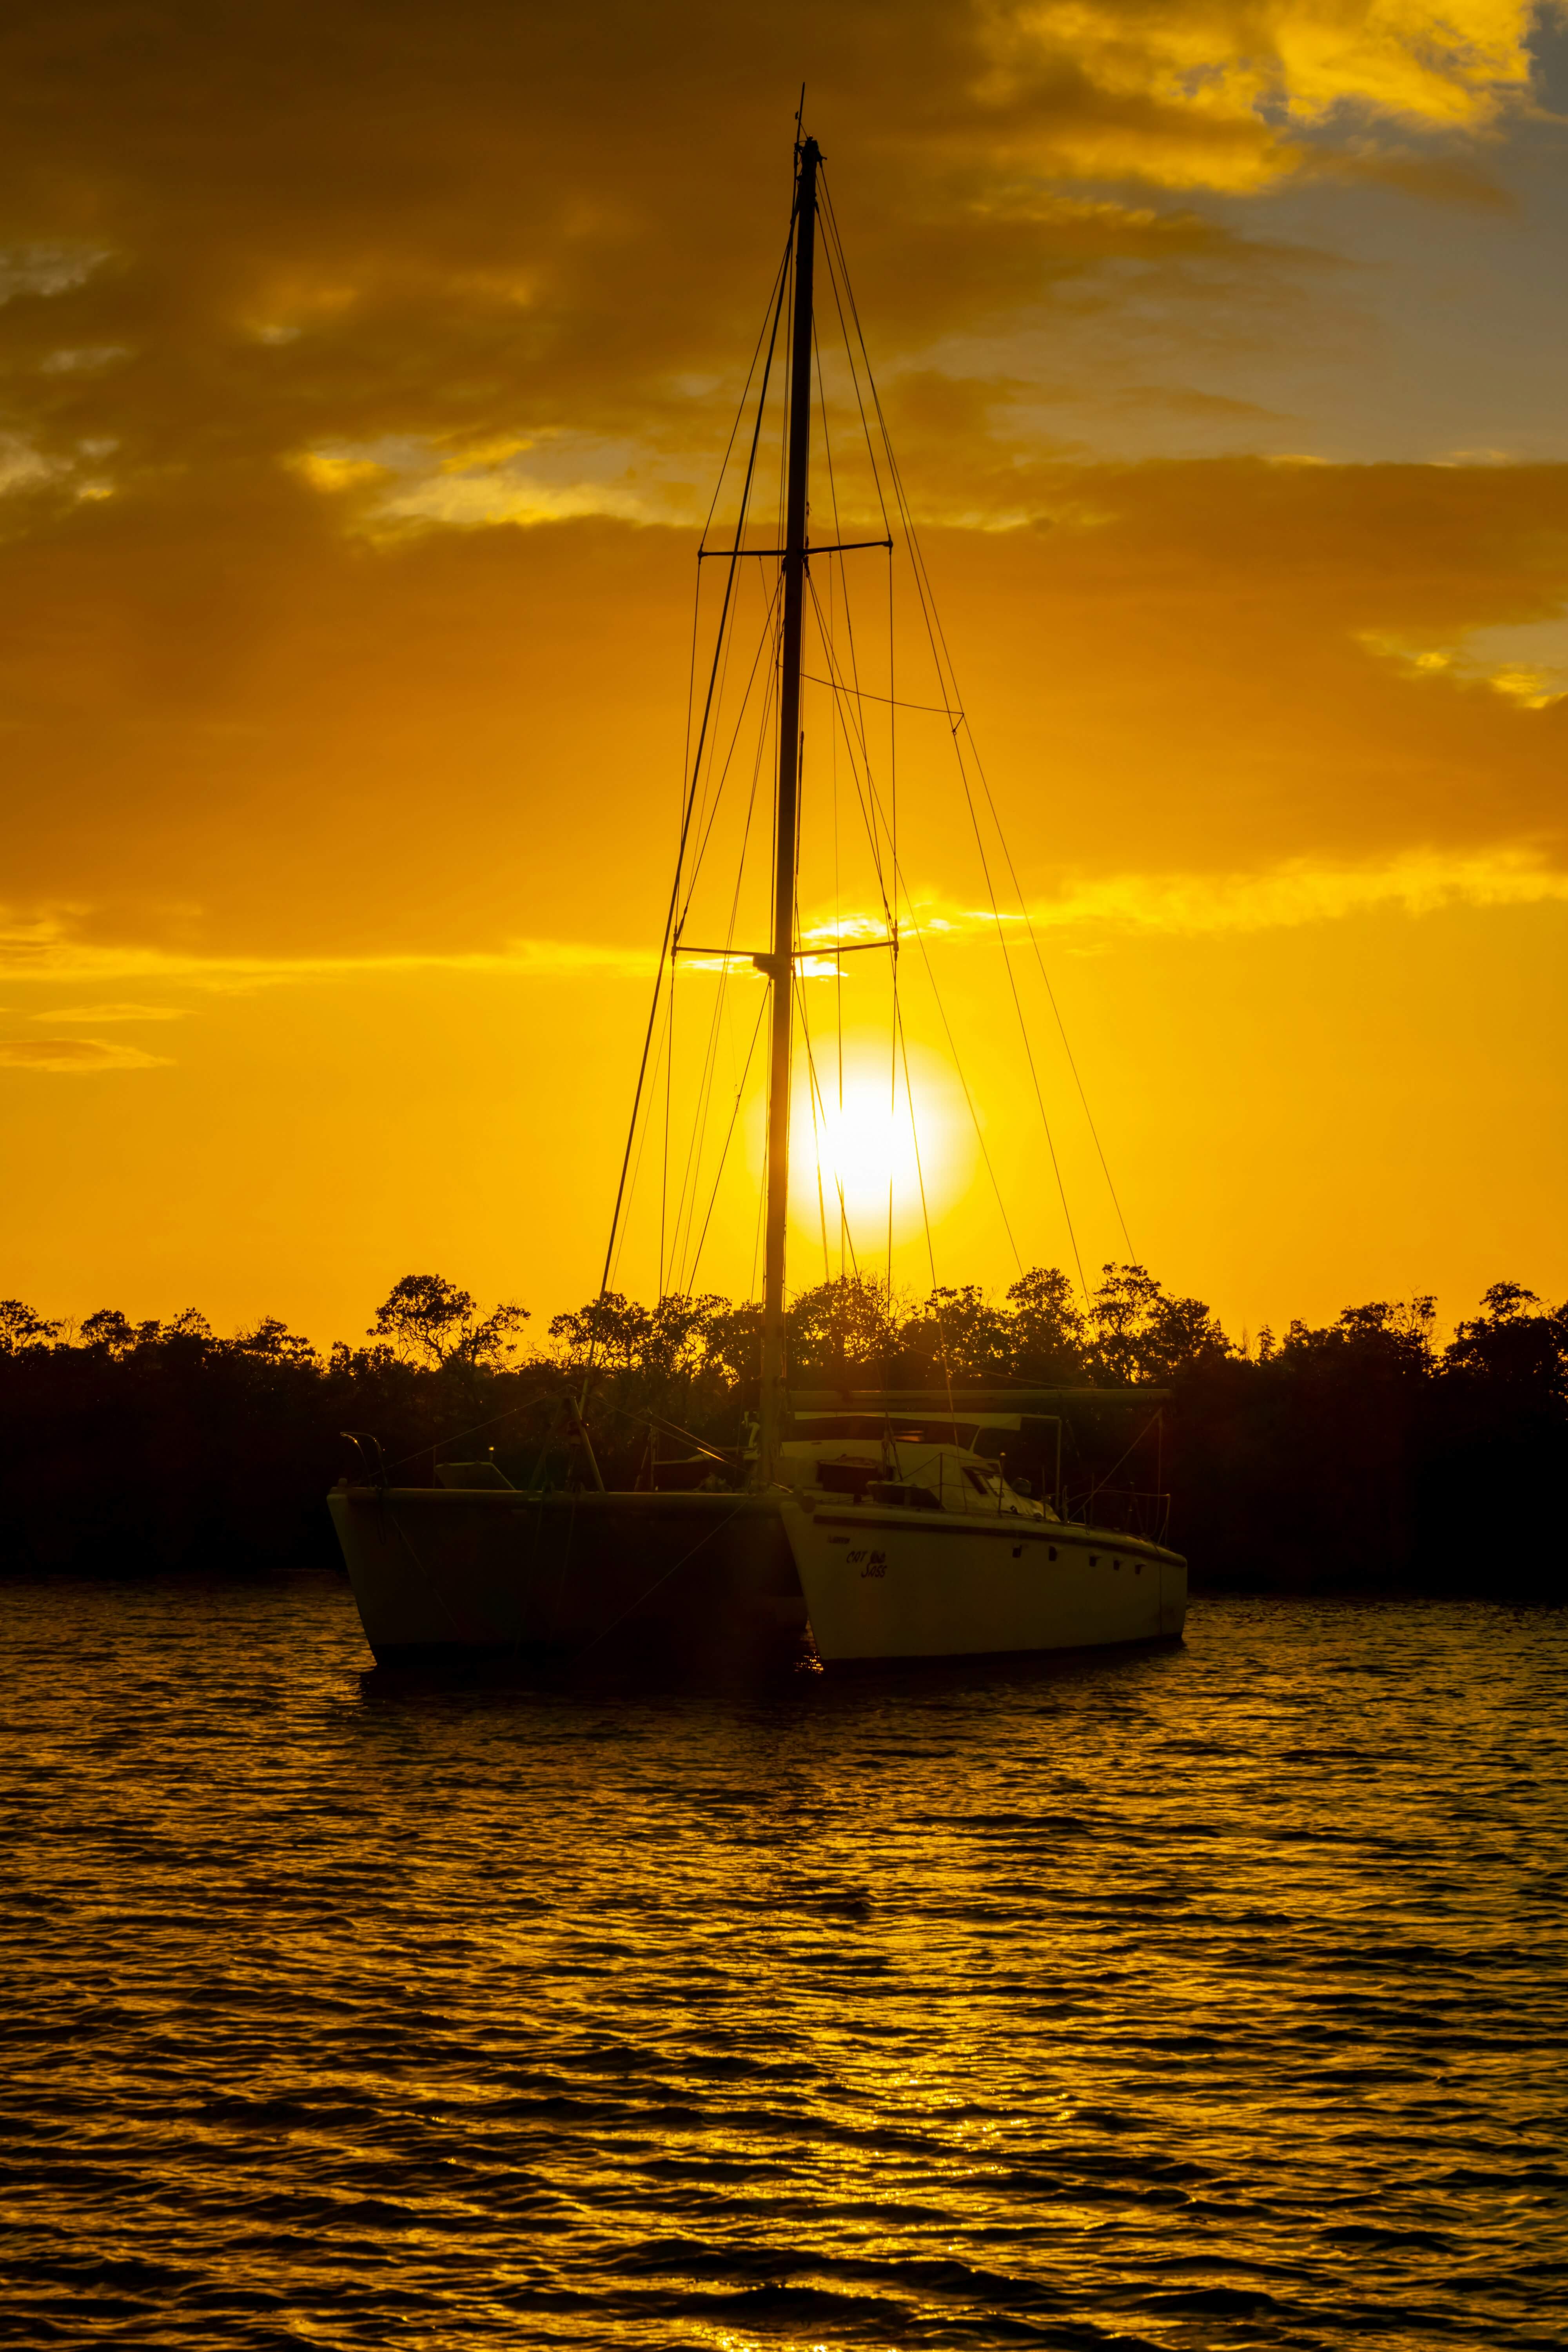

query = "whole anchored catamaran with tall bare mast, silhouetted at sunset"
[{"left": 329, "top": 122, "right": 1187, "bottom": 1668}]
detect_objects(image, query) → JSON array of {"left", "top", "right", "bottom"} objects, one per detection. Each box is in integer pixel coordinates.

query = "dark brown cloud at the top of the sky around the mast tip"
[{"left": 0, "top": 0, "right": 1507, "bottom": 492}]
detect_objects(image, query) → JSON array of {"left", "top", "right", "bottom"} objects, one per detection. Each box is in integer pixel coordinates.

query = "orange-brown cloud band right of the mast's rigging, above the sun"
[{"left": 921, "top": 461, "right": 1568, "bottom": 870}]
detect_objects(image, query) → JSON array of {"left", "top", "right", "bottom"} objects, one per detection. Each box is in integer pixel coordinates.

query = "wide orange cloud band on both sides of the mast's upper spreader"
[{"left": 0, "top": 454, "right": 1568, "bottom": 953}]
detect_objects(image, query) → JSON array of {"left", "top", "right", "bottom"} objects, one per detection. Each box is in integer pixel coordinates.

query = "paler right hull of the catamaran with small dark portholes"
[{"left": 783, "top": 1503, "right": 1187, "bottom": 1665}]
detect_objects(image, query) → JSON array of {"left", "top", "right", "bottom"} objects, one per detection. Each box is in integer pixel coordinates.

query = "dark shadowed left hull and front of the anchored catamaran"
[{"left": 329, "top": 1486, "right": 806, "bottom": 1665}]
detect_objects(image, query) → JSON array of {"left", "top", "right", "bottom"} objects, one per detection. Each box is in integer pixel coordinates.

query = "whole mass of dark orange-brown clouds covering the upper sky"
[{"left": 0, "top": 0, "right": 1566, "bottom": 953}]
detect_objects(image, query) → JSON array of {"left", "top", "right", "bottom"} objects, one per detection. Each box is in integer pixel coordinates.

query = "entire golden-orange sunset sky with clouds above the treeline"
[{"left": 0, "top": 0, "right": 1568, "bottom": 1341}]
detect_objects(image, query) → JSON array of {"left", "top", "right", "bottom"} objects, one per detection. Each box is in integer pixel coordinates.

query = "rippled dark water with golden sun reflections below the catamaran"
[{"left": 0, "top": 1585, "right": 1568, "bottom": 2352}]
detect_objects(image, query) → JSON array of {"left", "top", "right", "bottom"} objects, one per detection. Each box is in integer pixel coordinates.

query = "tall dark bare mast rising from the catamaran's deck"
[{"left": 759, "top": 139, "right": 823, "bottom": 1482}]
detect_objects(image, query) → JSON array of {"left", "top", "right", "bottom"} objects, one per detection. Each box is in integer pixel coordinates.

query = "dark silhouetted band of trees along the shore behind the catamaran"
[{"left": 0, "top": 1265, "right": 1568, "bottom": 1602}]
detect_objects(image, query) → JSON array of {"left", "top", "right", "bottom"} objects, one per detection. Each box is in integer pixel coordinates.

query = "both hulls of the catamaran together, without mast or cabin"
[{"left": 329, "top": 1486, "right": 1187, "bottom": 1668}]
